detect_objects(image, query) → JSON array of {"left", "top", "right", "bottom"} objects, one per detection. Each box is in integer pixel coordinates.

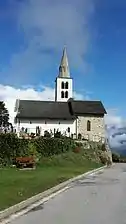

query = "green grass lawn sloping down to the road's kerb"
[{"left": 0, "top": 153, "right": 101, "bottom": 210}]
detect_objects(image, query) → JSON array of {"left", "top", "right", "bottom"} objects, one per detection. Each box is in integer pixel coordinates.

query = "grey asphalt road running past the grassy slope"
[{"left": 11, "top": 164, "right": 126, "bottom": 224}]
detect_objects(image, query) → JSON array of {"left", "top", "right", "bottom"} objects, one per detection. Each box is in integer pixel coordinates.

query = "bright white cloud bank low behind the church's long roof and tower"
[{"left": 0, "top": 85, "right": 87, "bottom": 122}]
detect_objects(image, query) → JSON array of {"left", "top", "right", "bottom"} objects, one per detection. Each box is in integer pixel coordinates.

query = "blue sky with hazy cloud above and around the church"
[{"left": 0, "top": 0, "right": 126, "bottom": 150}]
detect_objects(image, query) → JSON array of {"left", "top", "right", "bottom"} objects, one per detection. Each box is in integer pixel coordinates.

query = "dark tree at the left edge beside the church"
[{"left": 0, "top": 101, "right": 9, "bottom": 127}]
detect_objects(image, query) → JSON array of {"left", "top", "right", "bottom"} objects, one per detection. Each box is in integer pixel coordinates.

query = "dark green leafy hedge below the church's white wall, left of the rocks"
[{"left": 0, "top": 133, "right": 75, "bottom": 165}]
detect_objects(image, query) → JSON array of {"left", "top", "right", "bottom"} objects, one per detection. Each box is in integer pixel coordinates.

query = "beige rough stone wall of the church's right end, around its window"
[{"left": 77, "top": 116, "right": 105, "bottom": 141}]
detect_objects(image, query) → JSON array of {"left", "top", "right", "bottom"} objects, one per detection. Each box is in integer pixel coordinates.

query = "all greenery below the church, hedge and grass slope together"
[{"left": 0, "top": 134, "right": 108, "bottom": 210}]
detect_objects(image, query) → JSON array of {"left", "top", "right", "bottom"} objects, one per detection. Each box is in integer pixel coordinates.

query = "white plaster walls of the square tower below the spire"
[{"left": 55, "top": 78, "right": 73, "bottom": 102}]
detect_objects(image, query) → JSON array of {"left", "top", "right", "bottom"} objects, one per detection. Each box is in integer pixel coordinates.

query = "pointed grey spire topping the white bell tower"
[{"left": 58, "top": 47, "right": 70, "bottom": 78}]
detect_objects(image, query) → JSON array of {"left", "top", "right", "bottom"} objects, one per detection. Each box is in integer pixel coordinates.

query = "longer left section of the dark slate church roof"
[{"left": 17, "top": 100, "right": 74, "bottom": 119}]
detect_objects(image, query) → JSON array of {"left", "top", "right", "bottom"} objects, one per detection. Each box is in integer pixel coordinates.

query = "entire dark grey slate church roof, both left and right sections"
[{"left": 16, "top": 100, "right": 106, "bottom": 120}]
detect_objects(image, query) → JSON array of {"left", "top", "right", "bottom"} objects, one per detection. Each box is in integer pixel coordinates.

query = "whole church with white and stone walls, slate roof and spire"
[{"left": 15, "top": 48, "right": 106, "bottom": 141}]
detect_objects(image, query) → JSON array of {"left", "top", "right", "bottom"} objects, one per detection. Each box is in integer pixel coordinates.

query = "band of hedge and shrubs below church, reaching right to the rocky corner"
[{"left": 0, "top": 133, "right": 107, "bottom": 166}]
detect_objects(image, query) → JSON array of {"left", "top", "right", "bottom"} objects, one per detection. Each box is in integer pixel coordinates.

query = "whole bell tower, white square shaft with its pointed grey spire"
[{"left": 55, "top": 48, "right": 73, "bottom": 102}]
